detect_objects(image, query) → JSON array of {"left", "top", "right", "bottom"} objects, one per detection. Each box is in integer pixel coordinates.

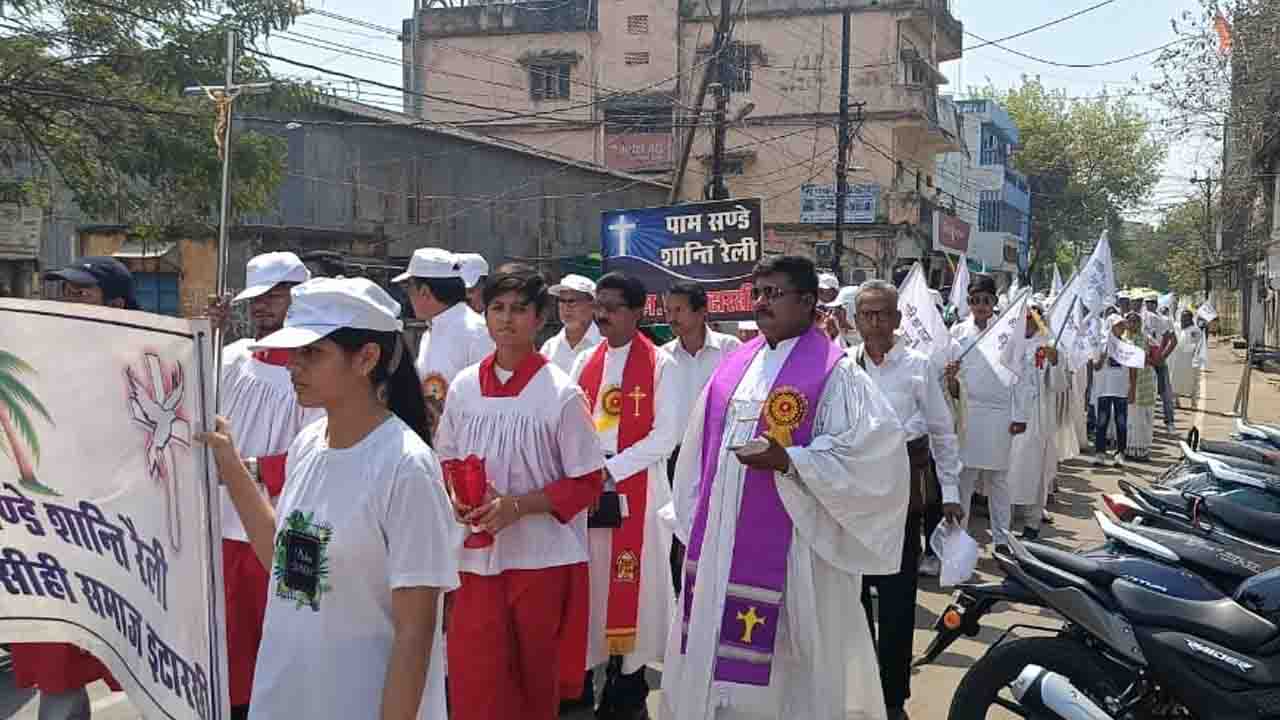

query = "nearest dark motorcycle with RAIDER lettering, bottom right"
[{"left": 919, "top": 512, "right": 1280, "bottom": 720}]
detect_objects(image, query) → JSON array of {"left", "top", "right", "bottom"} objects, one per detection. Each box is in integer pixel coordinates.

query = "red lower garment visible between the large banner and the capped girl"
[{"left": 223, "top": 539, "right": 269, "bottom": 706}]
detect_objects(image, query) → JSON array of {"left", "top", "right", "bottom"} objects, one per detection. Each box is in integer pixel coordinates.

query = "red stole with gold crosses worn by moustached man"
[{"left": 579, "top": 333, "right": 657, "bottom": 655}]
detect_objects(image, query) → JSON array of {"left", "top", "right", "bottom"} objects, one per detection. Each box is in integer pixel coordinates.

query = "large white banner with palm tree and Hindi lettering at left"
[{"left": 0, "top": 300, "right": 230, "bottom": 720}]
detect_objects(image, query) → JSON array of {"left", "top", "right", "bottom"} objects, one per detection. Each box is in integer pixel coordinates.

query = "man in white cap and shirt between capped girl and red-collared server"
[{"left": 392, "top": 247, "right": 493, "bottom": 412}]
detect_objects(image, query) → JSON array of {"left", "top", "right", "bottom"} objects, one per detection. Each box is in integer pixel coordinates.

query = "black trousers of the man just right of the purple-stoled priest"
[{"left": 863, "top": 512, "right": 923, "bottom": 710}]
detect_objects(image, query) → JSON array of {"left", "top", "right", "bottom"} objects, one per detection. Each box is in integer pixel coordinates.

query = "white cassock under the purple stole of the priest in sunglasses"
[{"left": 663, "top": 340, "right": 909, "bottom": 720}]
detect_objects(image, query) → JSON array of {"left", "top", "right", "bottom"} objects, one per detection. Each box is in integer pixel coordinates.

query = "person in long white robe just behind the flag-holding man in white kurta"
[{"left": 1009, "top": 305, "right": 1066, "bottom": 539}]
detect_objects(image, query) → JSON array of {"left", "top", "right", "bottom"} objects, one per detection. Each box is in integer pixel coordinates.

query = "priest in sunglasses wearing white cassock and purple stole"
[{"left": 663, "top": 256, "right": 909, "bottom": 720}]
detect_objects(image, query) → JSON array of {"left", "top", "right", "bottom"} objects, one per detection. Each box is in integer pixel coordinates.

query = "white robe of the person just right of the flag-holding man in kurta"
[{"left": 1009, "top": 336, "right": 1066, "bottom": 505}]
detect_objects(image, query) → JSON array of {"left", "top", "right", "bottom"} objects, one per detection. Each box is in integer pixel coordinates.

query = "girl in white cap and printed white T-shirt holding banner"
[{"left": 200, "top": 278, "right": 462, "bottom": 720}]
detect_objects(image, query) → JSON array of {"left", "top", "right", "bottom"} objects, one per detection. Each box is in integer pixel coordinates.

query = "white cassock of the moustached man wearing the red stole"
[{"left": 571, "top": 341, "right": 680, "bottom": 674}]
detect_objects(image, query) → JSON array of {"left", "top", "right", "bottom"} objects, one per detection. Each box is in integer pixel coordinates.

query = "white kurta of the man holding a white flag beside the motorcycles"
[{"left": 951, "top": 318, "right": 1027, "bottom": 470}]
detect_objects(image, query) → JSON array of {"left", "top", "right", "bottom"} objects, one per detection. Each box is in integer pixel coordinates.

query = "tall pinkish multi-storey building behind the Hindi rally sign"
[{"left": 403, "top": 0, "right": 963, "bottom": 280}]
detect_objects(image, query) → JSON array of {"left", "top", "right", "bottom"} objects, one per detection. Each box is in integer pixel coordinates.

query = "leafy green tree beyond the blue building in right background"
[{"left": 974, "top": 78, "right": 1167, "bottom": 275}]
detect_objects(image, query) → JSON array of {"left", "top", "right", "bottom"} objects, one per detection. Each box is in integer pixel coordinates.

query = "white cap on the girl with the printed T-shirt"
[{"left": 252, "top": 278, "right": 404, "bottom": 350}]
